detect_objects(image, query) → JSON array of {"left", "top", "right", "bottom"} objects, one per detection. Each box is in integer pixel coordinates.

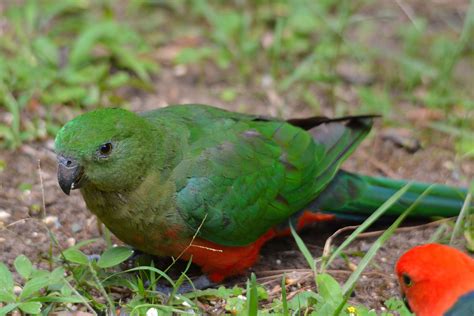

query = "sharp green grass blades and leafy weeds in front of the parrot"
[{"left": 0, "top": 184, "right": 469, "bottom": 316}]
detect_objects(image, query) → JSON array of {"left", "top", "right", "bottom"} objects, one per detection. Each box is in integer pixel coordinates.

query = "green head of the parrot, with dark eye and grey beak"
[{"left": 55, "top": 108, "right": 155, "bottom": 195}]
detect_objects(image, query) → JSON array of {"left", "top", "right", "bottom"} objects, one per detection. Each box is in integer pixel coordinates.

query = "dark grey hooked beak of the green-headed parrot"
[{"left": 58, "top": 155, "right": 84, "bottom": 195}]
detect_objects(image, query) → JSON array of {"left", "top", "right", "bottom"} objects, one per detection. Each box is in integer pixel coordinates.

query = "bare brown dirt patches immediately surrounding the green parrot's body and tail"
[{"left": 0, "top": 67, "right": 474, "bottom": 310}]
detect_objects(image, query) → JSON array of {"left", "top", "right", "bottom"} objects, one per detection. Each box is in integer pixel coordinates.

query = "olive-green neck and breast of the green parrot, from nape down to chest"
[{"left": 81, "top": 116, "right": 192, "bottom": 254}]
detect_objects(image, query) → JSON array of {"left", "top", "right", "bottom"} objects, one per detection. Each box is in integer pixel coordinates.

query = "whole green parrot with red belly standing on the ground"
[{"left": 55, "top": 105, "right": 467, "bottom": 282}]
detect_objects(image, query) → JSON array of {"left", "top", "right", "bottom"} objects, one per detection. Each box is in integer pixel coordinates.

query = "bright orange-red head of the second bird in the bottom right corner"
[{"left": 395, "top": 243, "right": 474, "bottom": 316}]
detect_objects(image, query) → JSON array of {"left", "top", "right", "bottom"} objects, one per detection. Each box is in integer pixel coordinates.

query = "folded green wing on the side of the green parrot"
[{"left": 156, "top": 105, "right": 371, "bottom": 246}]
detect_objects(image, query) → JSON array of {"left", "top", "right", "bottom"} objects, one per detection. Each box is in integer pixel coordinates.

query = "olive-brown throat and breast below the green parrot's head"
[{"left": 81, "top": 171, "right": 192, "bottom": 255}]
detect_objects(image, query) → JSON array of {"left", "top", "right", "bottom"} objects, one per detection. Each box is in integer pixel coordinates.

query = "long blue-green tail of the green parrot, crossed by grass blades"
[{"left": 307, "top": 170, "right": 474, "bottom": 217}]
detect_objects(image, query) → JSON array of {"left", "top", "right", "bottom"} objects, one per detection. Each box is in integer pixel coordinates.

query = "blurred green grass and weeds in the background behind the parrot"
[{"left": 0, "top": 0, "right": 474, "bottom": 156}]
